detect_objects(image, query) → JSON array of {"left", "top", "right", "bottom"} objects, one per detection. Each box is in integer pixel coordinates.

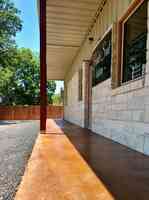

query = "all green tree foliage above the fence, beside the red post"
[{"left": 0, "top": 0, "right": 56, "bottom": 105}]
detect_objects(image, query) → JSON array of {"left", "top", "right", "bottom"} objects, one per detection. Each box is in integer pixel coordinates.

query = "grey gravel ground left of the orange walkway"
[{"left": 0, "top": 121, "right": 39, "bottom": 200}]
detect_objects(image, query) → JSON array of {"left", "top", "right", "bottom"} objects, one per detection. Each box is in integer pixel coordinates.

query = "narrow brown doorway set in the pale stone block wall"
[{"left": 83, "top": 60, "right": 92, "bottom": 128}]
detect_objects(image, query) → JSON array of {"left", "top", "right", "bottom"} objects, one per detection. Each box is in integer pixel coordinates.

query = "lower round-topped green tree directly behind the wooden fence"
[{"left": 0, "top": 48, "right": 56, "bottom": 105}]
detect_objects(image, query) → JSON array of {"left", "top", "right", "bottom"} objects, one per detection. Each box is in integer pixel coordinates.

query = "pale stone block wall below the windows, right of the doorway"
[{"left": 92, "top": 76, "right": 149, "bottom": 155}]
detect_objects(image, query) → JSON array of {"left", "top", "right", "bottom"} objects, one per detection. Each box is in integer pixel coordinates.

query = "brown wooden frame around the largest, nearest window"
[{"left": 117, "top": 0, "right": 146, "bottom": 86}]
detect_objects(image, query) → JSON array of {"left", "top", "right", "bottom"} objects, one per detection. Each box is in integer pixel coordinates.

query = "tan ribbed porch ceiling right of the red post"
[{"left": 47, "top": 0, "right": 102, "bottom": 80}]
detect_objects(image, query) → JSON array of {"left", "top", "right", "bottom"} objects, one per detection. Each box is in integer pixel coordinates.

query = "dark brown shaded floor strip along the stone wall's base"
[{"left": 56, "top": 120, "right": 149, "bottom": 200}]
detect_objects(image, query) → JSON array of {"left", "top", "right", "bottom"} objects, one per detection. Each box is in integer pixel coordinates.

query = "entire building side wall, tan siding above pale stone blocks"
[{"left": 65, "top": 0, "right": 149, "bottom": 155}]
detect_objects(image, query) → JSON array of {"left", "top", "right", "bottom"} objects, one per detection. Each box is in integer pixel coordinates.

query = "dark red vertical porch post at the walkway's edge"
[{"left": 40, "top": 0, "right": 47, "bottom": 133}]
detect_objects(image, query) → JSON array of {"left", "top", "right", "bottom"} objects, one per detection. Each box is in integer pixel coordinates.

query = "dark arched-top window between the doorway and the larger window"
[{"left": 91, "top": 31, "right": 112, "bottom": 87}]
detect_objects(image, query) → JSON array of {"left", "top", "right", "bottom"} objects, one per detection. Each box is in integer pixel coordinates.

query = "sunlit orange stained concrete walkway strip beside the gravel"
[{"left": 15, "top": 120, "right": 113, "bottom": 200}]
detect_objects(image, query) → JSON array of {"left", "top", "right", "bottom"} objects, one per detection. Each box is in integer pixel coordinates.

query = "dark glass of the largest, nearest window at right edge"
[{"left": 122, "top": 0, "right": 147, "bottom": 83}]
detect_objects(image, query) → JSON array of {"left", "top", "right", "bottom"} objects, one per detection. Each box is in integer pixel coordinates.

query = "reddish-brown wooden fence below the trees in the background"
[{"left": 0, "top": 105, "right": 64, "bottom": 120}]
